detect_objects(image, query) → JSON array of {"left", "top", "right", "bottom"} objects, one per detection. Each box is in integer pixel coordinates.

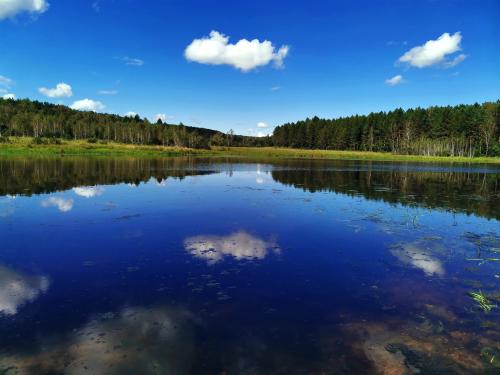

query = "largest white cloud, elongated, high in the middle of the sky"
[{"left": 184, "top": 31, "right": 290, "bottom": 72}]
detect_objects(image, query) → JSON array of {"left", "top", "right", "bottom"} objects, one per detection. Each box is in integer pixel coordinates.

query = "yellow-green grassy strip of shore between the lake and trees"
[{"left": 0, "top": 138, "right": 500, "bottom": 164}]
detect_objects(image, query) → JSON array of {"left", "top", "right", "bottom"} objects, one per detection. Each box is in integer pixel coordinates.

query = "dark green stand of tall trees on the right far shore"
[{"left": 272, "top": 101, "right": 500, "bottom": 157}]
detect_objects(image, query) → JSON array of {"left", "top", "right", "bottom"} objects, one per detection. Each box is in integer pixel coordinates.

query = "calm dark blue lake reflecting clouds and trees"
[{"left": 0, "top": 158, "right": 500, "bottom": 375}]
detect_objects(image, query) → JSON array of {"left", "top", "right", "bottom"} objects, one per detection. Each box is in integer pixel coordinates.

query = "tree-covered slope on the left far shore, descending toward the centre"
[{"left": 0, "top": 99, "right": 264, "bottom": 148}]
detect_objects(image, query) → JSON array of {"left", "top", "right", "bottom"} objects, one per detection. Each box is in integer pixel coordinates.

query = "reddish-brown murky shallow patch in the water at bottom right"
[{"left": 345, "top": 318, "right": 486, "bottom": 375}]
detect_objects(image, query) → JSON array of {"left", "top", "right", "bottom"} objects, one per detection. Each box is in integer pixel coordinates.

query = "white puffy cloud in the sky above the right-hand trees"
[{"left": 398, "top": 32, "right": 465, "bottom": 68}]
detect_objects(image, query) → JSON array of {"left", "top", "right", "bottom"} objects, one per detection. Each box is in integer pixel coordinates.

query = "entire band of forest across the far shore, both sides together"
[{"left": 0, "top": 99, "right": 500, "bottom": 157}]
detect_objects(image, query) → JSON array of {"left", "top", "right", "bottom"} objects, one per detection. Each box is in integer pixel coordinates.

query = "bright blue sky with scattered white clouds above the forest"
[{"left": 0, "top": 0, "right": 500, "bottom": 134}]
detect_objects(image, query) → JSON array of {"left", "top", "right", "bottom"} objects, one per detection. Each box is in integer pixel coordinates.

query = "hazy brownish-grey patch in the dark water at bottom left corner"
[{"left": 0, "top": 306, "right": 194, "bottom": 375}]
